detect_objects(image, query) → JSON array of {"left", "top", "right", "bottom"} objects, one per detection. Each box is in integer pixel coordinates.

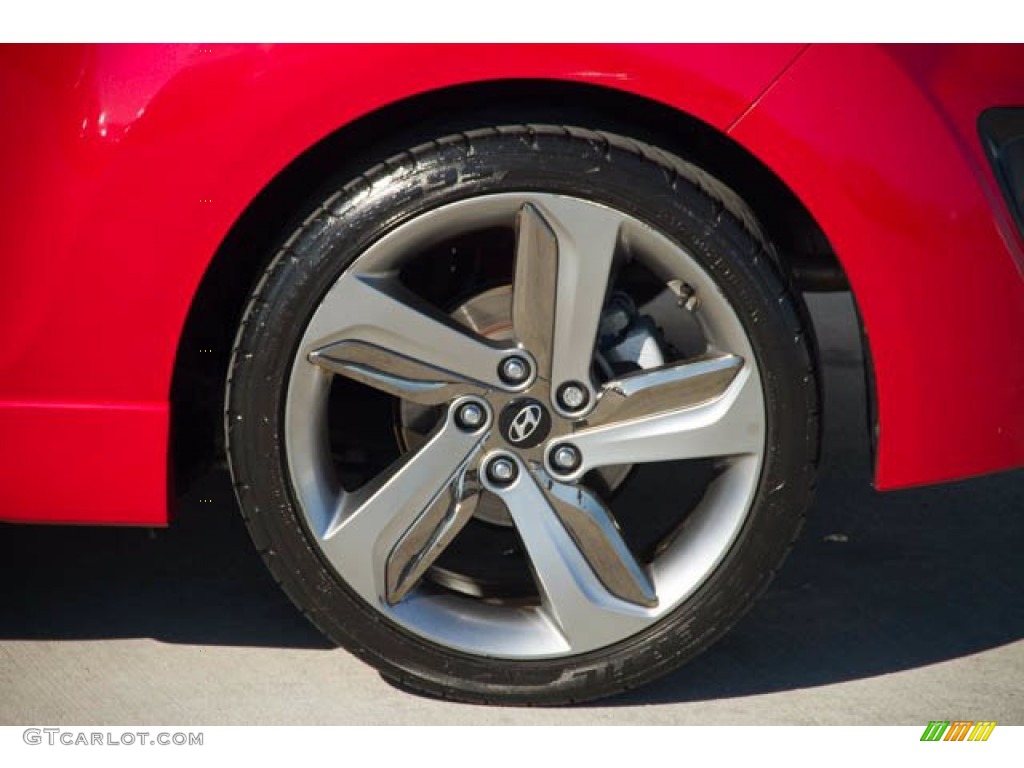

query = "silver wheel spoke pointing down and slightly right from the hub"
[{"left": 501, "top": 472, "right": 654, "bottom": 647}]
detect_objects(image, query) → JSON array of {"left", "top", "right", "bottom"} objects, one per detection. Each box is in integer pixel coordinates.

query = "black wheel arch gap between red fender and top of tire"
[{"left": 171, "top": 80, "right": 847, "bottom": 495}]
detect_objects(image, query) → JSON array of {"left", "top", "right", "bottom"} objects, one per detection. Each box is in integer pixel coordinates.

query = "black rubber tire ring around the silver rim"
[{"left": 225, "top": 126, "right": 819, "bottom": 705}]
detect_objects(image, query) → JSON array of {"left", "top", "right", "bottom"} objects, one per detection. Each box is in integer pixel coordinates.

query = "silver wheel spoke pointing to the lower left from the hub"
[{"left": 322, "top": 415, "right": 485, "bottom": 603}]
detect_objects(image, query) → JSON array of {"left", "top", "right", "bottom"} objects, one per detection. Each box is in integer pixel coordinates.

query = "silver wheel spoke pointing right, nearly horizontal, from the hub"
[{"left": 570, "top": 355, "right": 765, "bottom": 477}]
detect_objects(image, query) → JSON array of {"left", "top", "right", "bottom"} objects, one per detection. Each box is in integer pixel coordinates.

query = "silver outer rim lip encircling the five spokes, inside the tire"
[{"left": 284, "top": 191, "right": 766, "bottom": 659}]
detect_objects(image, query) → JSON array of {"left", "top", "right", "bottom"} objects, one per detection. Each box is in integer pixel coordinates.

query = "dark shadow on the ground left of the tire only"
[{"left": 0, "top": 471, "right": 333, "bottom": 648}]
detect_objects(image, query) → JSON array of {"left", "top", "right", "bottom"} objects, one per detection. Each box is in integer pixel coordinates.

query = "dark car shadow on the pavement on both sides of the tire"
[{"left": 0, "top": 294, "right": 1024, "bottom": 706}]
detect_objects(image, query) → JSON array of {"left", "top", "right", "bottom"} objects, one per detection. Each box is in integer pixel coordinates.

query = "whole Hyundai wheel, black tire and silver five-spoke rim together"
[{"left": 227, "top": 128, "right": 817, "bottom": 701}]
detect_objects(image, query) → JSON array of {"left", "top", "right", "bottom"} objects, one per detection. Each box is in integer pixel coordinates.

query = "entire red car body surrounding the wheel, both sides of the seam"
[{"left": 0, "top": 45, "right": 1024, "bottom": 525}]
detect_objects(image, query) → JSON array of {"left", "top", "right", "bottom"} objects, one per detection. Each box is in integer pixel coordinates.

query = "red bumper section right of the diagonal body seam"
[{"left": 730, "top": 45, "right": 1024, "bottom": 488}]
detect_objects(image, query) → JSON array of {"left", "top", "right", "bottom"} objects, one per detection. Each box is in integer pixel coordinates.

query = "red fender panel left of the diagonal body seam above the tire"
[{"left": 0, "top": 45, "right": 801, "bottom": 524}]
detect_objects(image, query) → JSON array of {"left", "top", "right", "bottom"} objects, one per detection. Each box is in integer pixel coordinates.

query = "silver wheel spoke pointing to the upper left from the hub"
[{"left": 305, "top": 274, "right": 506, "bottom": 406}]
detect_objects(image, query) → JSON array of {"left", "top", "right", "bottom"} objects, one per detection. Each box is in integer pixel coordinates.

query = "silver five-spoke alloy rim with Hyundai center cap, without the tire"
[{"left": 286, "top": 194, "right": 764, "bottom": 658}]
